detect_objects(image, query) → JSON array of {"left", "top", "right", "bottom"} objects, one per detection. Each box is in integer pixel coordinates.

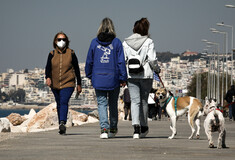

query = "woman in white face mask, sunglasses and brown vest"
[{"left": 45, "top": 32, "right": 82, "bottom": 134}]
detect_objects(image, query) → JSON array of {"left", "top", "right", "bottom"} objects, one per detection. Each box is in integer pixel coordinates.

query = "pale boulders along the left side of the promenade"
[{"left": 0, "top": 103, "right": 98, "bottom": 133}]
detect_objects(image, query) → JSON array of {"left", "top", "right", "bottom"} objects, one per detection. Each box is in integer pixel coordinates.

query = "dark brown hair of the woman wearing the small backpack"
[{"left": 133, "top": 18, "right": 150, "bottom": 36}]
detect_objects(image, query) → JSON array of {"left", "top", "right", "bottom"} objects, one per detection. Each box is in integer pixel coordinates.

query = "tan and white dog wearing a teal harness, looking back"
[{"left": 155, "top": 88, "right": 203, "bottom": 139}]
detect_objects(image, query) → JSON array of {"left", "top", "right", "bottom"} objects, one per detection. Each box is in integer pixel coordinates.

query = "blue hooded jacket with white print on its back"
[{"left": 85, "top": 38, "right": 127, "bottom": 90}]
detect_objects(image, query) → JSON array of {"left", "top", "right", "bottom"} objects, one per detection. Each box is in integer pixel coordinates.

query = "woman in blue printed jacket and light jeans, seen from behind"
[{"left": 85, "top": 18, "right": 127, "bottom": 139}]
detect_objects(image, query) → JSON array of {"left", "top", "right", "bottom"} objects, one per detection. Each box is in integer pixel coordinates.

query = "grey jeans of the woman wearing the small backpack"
[{"left": 128, "top": 79, "right": 153, "bottom": 126}]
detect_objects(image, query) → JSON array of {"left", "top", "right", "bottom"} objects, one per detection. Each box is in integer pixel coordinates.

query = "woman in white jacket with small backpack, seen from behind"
[{"left": 123, "top": 18, "right": 156, "bottom": 139}]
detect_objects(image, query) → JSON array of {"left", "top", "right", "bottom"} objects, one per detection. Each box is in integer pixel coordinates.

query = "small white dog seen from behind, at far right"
[{"left": 204, "top": 98, "right": 226, "bottom": 149}]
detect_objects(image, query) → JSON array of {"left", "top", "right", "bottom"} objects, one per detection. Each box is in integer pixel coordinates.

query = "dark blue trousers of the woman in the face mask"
[{"left": 51, "top": 87, "right": 74, "bottom": 123}]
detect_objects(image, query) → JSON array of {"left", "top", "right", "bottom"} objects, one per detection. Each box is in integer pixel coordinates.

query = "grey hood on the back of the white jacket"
[{"left": 125, "top": 33, "right": 148, "bottom": 51}]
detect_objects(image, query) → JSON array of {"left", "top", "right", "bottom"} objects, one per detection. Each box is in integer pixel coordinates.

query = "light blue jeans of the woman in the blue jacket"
[{"left": 95, "top": 87, "right": 120, "bottom": 129}]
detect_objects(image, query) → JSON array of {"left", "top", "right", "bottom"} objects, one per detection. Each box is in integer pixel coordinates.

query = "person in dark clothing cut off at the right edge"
[{"left": 225, "top": 85, "right": 235, "bottom": 121}]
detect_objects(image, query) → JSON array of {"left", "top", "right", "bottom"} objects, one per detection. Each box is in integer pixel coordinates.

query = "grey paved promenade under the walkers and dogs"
[{"left": 0, "top": 117, "right": 235, "bottom": 160}]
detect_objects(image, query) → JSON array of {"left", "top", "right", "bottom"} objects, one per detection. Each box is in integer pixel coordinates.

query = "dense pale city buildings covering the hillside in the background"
[{"left": 0, "top": 51, "right": 235, "bottom": 106}]
